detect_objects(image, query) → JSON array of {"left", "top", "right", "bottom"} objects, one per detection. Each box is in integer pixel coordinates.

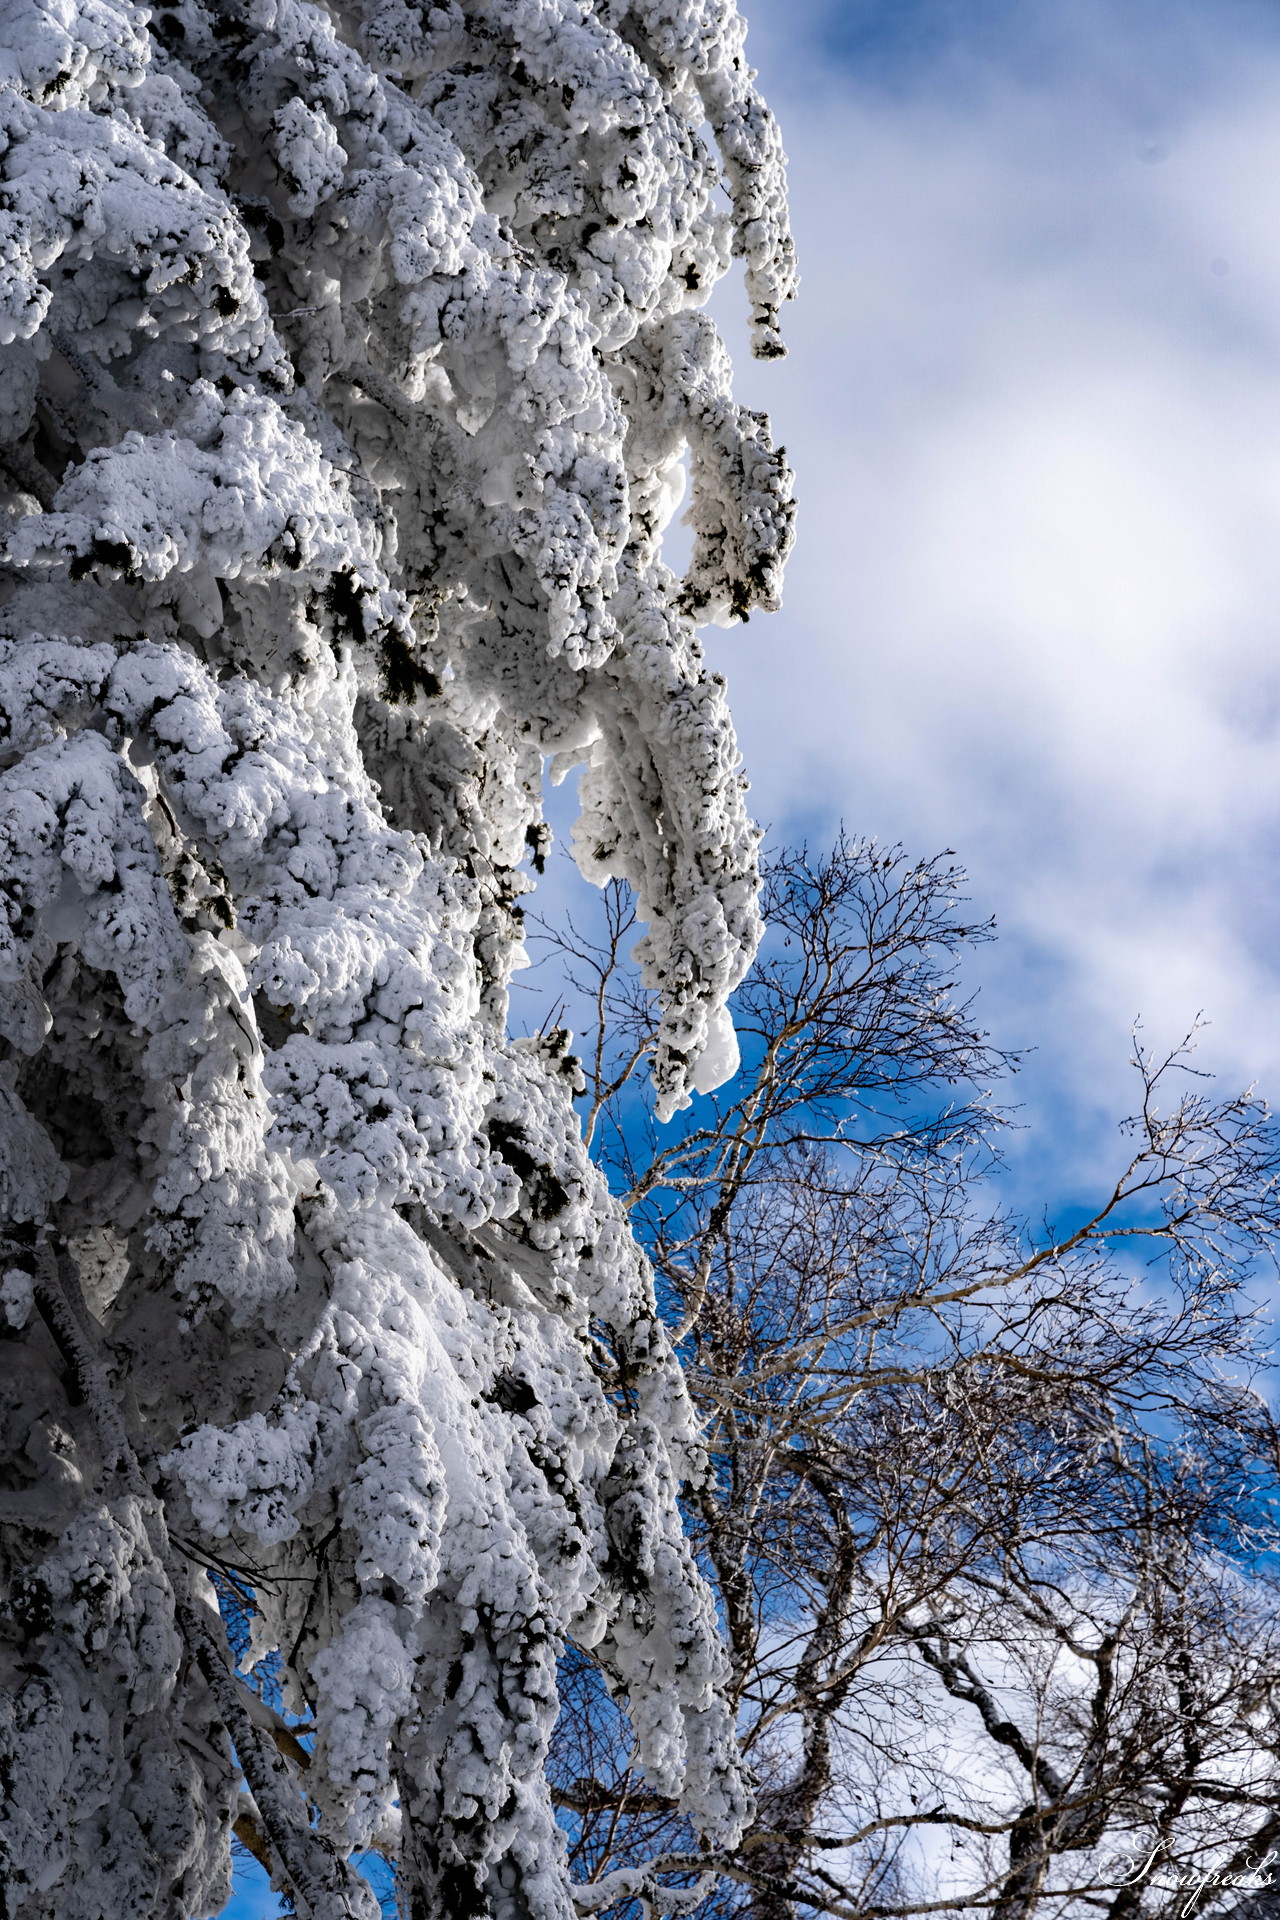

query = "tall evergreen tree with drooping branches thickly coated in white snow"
[{"left": 0, "top": 0, "right": 793, "bottom": 1920}]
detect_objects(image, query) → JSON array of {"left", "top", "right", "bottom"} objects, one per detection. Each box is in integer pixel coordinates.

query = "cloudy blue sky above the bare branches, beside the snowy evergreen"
[{"left": 213, "top": 0, "right": 1280, "bottom": 1920}]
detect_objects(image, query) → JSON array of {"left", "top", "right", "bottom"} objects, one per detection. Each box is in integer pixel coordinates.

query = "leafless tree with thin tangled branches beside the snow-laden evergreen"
[{"left": 545, "top": 839, "right": 1280, "bottom": 1920}]
